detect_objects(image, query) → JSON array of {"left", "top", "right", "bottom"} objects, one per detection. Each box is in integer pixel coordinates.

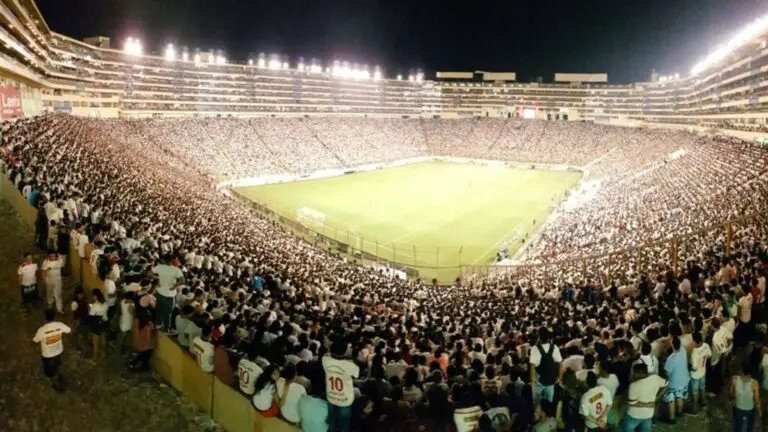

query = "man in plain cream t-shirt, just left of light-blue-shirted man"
[{"left": 622, "top": 363, "right": 667, "bottom": 431}]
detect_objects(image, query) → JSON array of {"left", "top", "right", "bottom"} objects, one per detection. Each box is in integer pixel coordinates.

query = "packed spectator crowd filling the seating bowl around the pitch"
[{"left": 0, "top": 116, "right": 768, "bottom": 432}]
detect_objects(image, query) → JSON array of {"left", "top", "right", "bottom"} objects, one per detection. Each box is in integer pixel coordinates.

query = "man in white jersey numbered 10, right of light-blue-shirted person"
[{"left": 322, "top": 341, "right": 360, "bottom": 432}]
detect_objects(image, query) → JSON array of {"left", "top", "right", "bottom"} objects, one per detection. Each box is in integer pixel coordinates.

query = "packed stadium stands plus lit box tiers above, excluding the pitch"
[{"left": 0, "top": 0, "right": 768, "bottom": 431}]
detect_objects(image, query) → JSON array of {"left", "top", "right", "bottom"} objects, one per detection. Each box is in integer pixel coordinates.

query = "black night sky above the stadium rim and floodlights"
[{"left": 38, "top": 0, "right": 768, "bottom": 83}]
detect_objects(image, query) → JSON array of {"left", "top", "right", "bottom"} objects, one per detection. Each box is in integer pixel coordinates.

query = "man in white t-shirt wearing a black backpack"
[{"left": 530, "top": 327, "right": 563, "bottom": 404}]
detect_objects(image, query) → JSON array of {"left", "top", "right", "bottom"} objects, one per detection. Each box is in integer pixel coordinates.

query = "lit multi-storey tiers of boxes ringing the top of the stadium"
[{"left": 0, "top": 0, "right": 768, "bottom": 139}]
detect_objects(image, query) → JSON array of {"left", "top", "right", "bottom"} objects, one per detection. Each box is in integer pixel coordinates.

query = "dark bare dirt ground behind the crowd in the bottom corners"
[{"left": 0, "top": 197, "right": 752, "bottom": 432}]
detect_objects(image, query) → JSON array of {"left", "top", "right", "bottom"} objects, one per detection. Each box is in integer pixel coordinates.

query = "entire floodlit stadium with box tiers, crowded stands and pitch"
[{"left": 0, "top": 0, "right": 768, "bottom": 431}]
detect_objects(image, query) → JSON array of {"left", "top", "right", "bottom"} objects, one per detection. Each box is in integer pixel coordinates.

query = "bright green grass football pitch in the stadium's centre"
[{"left": 237, "top": 162, "right": 581, "bottom": 279}]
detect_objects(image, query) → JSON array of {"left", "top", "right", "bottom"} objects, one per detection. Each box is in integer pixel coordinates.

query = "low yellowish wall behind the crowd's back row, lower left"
[{"left": 0, "top": 174, "right": 300, "bottom": 432}]
